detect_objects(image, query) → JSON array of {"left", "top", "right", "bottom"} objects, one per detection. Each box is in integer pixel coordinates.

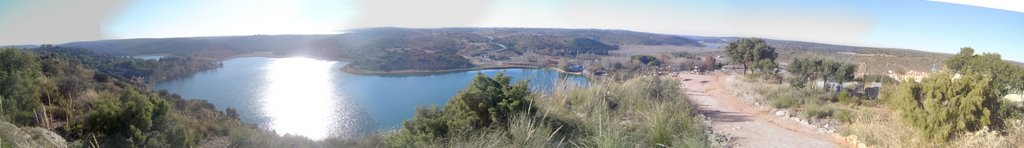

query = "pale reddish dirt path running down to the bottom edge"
[{"left": 678, "top": 75, "right": 845, "bottom": 148}]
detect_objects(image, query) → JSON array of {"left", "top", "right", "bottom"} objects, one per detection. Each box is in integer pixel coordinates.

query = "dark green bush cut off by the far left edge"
[{"left": 0, "top": 48, "right": 43, "bottom": 125}]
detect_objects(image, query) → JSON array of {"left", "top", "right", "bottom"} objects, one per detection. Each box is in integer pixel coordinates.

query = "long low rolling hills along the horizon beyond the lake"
[{"left": 48, "top": 28, "right": 970, "bottom": 73}]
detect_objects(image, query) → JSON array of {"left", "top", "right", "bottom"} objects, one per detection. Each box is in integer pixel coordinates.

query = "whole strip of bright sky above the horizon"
[{"left": 0, "top": 0, "right": 1024, "bottom": 61}]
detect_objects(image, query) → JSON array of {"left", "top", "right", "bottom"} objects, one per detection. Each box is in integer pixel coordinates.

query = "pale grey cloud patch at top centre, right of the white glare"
[{"left": 349, "top": 0, "right": 492, "bottom": 28}]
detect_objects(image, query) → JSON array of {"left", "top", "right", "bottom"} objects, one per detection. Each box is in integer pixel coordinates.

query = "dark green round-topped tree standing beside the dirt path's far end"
[{"left": 725, "top": 38, "right": 777, "bottom": 72}]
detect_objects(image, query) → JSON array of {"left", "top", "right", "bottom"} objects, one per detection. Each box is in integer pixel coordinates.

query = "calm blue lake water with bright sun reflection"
[{"left": 156, "top": 57, "right": 586, "bottom": 139}]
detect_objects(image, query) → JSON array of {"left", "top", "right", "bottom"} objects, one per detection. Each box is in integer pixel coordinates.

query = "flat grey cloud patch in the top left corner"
[{"left": 0, "top": 0, "right": 124, "bottom": 45}]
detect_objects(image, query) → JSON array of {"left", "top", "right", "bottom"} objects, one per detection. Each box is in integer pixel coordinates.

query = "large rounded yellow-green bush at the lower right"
[{"left": 889, "top": 73, "right": 1002, "bottom": 141}]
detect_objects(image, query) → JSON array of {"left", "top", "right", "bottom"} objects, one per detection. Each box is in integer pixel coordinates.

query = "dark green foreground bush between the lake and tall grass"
[{"left": 388, "top": 72, "right": 535, "bottom": 145}]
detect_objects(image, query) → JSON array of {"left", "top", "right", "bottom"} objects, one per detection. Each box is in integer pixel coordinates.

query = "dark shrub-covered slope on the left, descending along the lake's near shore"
[{"left": 0, "top": 49, "right": 335, "bottom": 147}]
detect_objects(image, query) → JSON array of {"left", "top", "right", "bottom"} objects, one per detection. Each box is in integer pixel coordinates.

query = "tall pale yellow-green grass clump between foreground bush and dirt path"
[{"left": 386, "top": 73, "right": 710, "bottom": 147}]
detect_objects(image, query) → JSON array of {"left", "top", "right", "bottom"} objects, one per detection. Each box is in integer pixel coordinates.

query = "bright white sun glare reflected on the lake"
[{"left": 261, "top": 57, "right": 338, "bottom": 140}]
